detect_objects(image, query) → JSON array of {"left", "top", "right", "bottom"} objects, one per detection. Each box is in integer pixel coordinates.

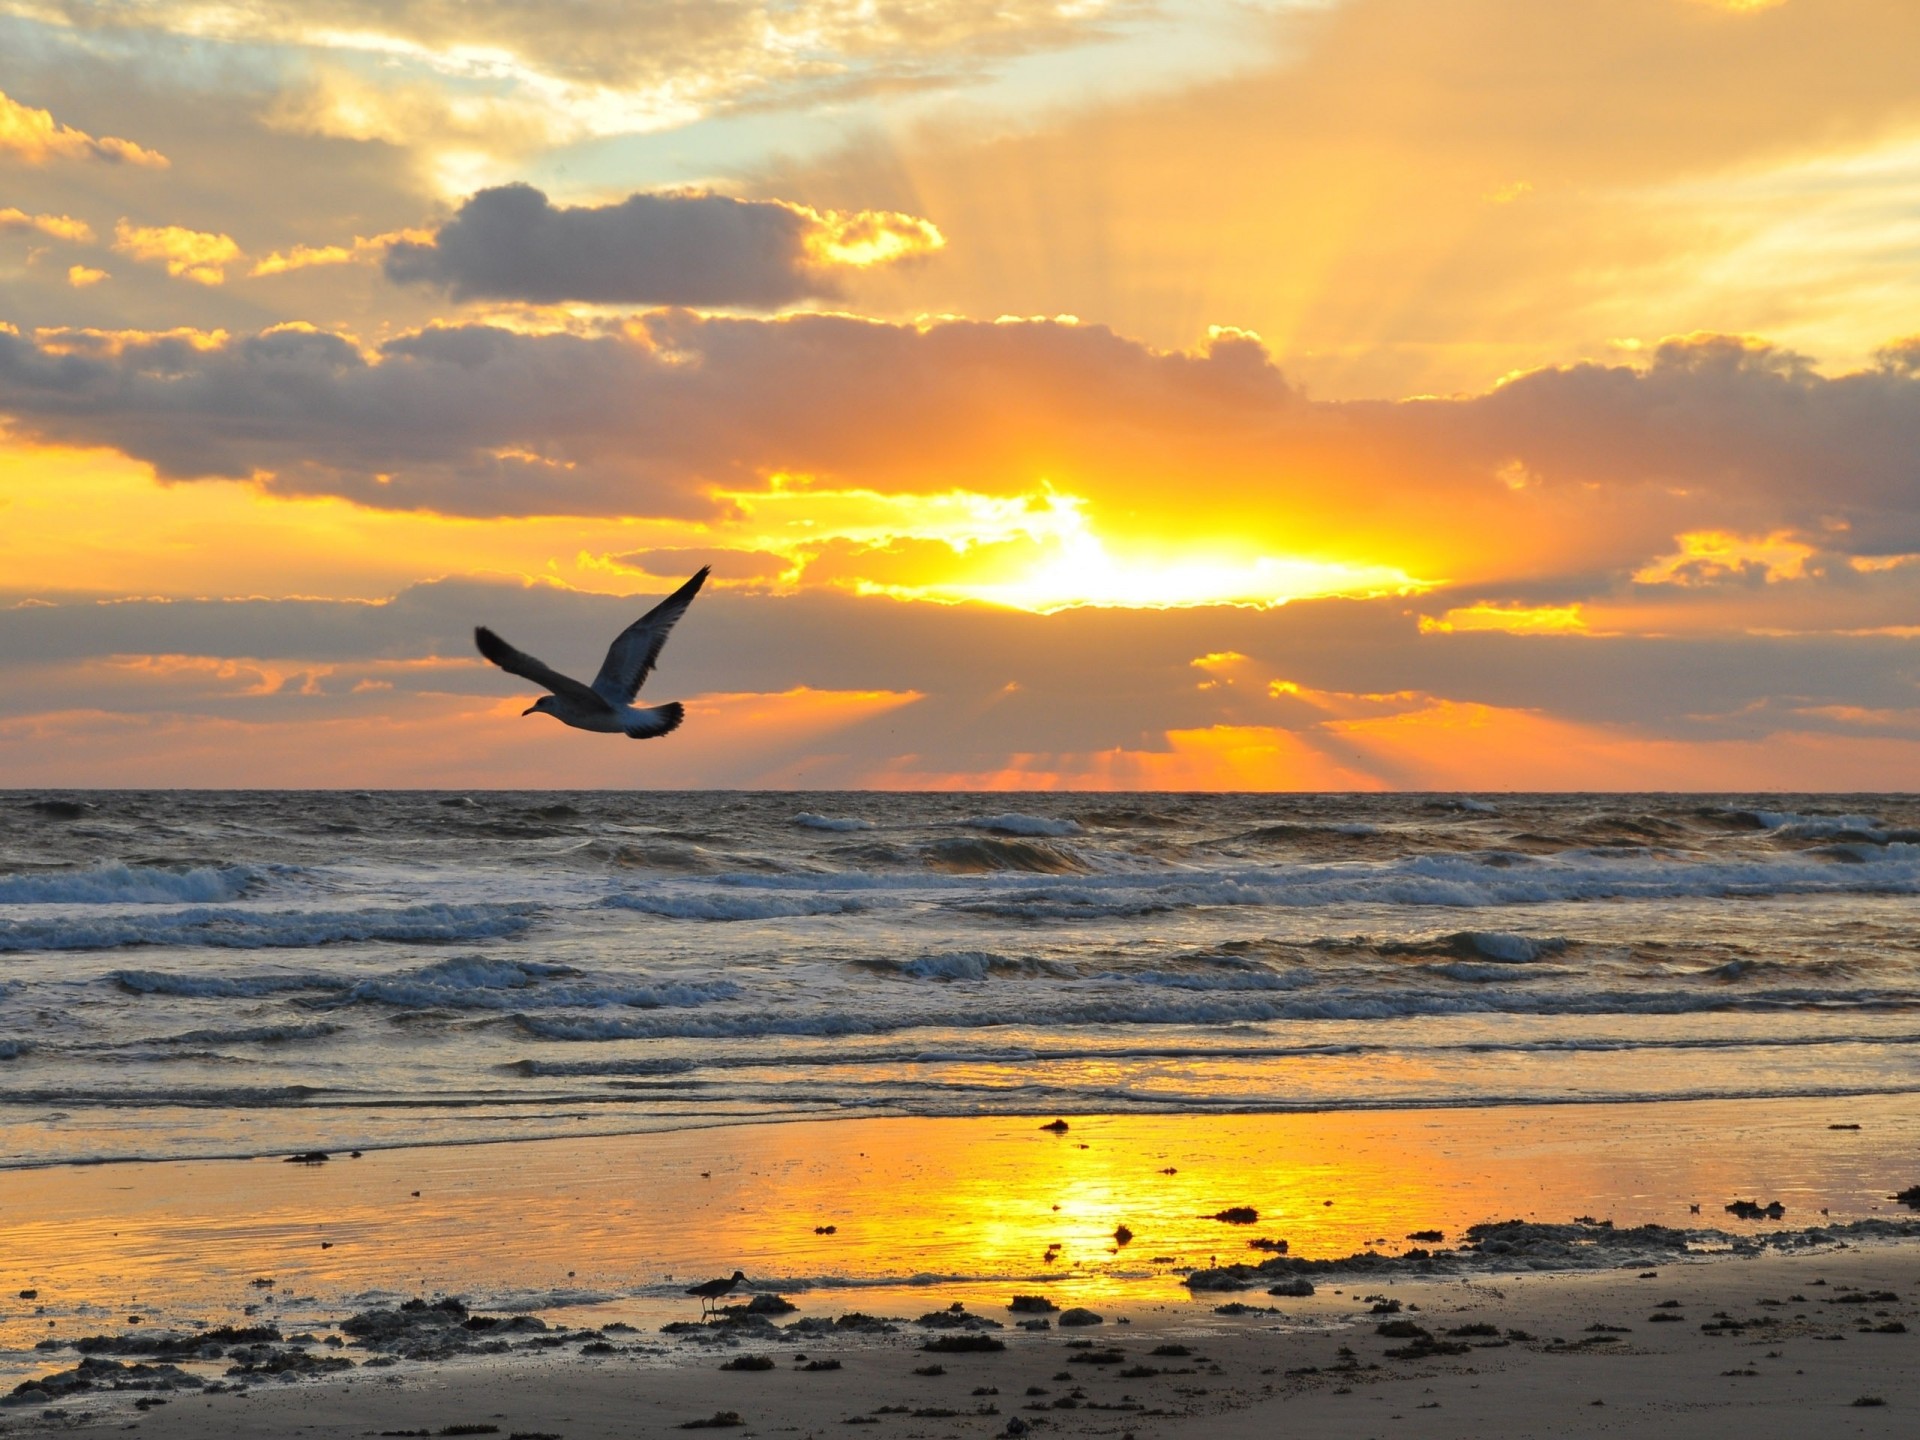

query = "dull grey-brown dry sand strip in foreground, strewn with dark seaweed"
[{"left": 0, "top": 1244, "right": 1920, "bottom": 1440}]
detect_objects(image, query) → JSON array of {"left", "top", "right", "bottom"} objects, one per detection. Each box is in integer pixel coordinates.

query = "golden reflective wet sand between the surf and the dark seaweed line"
[{"left": 0, "top": 1096, "right": 1920, "bottom": 1350}]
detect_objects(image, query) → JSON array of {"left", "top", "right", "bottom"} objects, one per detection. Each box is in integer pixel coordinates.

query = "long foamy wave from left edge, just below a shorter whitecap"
[{"left": 0, "top": 904, "right": 536, "bottom": 952}]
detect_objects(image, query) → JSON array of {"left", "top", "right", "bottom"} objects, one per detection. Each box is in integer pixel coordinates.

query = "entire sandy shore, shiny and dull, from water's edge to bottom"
[{"left": 0, "top": 1096, "right": 1920, "bottom": 1440}]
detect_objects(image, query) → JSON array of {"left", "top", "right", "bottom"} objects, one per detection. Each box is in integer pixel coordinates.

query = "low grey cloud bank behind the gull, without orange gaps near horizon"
[{"left": 0, "top": 580, "right": 1920, "bottom": 770}]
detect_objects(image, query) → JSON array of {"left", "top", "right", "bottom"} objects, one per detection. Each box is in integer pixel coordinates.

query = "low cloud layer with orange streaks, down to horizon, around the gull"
[{"left": 0, "top": 580, "right": 1920, "bottom": 789}]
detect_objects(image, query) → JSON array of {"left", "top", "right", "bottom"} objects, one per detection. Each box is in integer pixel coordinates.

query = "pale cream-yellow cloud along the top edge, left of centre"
[{"left": 12, "top": 0, "right": 1135, "bottom": 140}]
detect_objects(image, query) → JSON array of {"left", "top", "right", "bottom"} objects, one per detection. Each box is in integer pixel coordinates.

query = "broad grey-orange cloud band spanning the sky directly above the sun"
[{"left": 0, "top": 311, "right": 1920, "bottom": 607}]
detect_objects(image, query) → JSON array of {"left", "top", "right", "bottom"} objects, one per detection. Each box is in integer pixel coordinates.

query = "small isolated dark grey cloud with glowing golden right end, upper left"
[{"left": 386, "top": 184, "right": 945, "bottom": 309}]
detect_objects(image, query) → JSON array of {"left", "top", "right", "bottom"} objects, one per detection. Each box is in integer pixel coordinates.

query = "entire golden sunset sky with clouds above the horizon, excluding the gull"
[{"left": 0, "top": 0, "right": 1920, "bottom": 791}]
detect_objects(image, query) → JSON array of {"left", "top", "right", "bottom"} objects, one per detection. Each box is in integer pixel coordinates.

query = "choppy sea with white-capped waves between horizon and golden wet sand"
[{"left": 0, "top": 791, "right": 1920, "bottom": 1169}]
